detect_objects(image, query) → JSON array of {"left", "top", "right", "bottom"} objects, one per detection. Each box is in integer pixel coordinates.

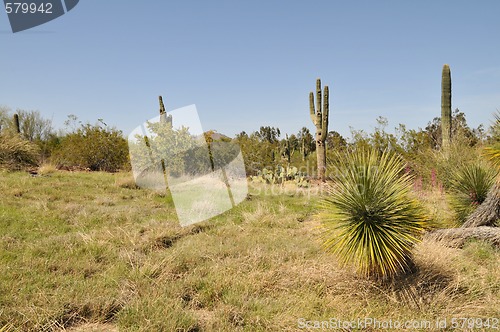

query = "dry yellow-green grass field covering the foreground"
[{"left": 0, "top": 171, "right": 500, "bottom": 332}]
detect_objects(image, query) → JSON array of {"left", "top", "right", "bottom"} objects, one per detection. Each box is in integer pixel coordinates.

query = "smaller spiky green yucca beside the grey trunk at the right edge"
[{"left": 450, "top": 164, "right": 497, "bottom": 222}]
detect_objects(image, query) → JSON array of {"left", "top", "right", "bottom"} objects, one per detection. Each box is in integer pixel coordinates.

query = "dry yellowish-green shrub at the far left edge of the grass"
[{"left": 0, "top": 132, "right": 39, "bottom": 170}]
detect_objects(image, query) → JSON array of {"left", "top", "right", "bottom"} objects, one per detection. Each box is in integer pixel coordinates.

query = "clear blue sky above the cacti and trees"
[{"left": 0, "top": 0, "right": 500, "bottom": 136}]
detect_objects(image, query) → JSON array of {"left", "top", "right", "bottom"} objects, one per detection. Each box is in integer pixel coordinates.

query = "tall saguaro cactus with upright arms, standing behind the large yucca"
[{"left": 309, "top": 78, "right": 330, "bottom": 182}]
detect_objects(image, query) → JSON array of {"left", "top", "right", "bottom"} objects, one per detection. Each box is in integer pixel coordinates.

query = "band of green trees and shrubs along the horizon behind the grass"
[{"left": 0, "top": 107, "right": 494, "bottom": 182}]
